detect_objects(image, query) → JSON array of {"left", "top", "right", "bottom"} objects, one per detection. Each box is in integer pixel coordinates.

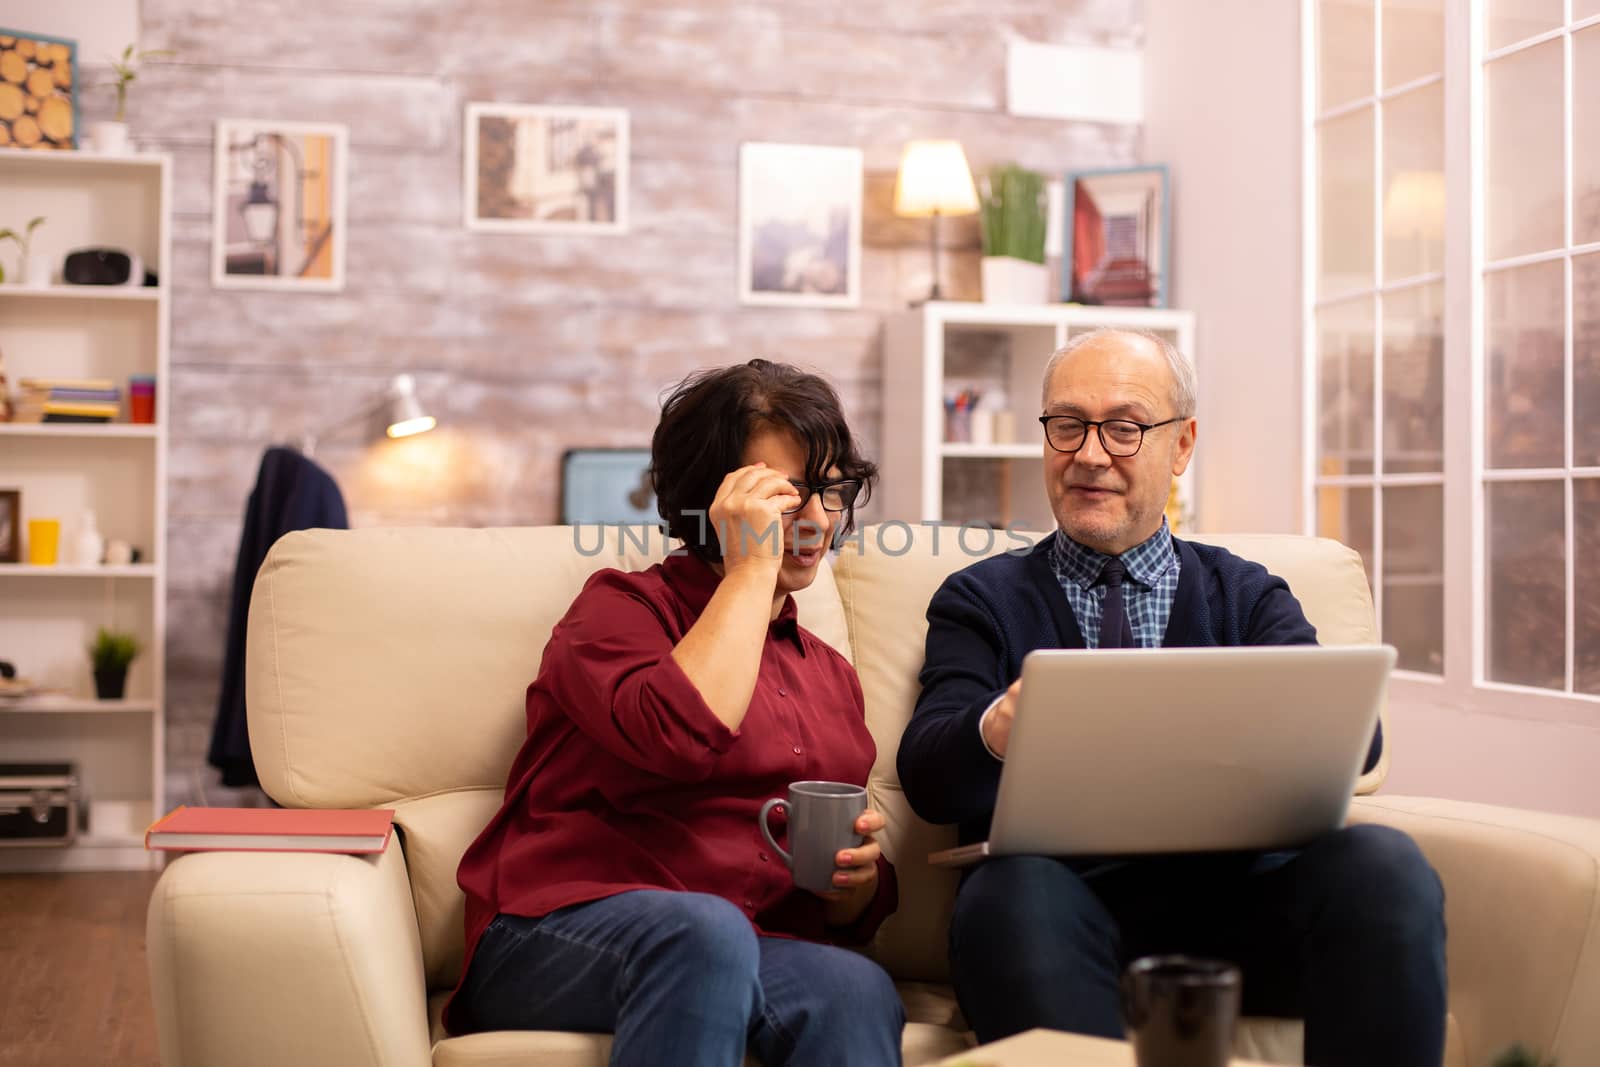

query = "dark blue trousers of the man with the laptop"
[{"left": 950, "top": 825, "right": 1445, "bottom": 1067}]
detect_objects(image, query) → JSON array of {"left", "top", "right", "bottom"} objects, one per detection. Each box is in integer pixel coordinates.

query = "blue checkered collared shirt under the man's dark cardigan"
[{"left": 1050, "top": 518, "right": 1179, "bottom": 648}]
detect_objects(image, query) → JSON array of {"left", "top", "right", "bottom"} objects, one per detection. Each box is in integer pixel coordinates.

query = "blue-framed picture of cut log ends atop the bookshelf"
[{"left": 0, "top": 29, "right": 78, "bottom": 149}]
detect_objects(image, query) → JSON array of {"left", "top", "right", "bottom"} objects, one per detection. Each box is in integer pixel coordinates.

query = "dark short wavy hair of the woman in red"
[{"left": 650, "top": 360, "right": 878, "bottom": 563}]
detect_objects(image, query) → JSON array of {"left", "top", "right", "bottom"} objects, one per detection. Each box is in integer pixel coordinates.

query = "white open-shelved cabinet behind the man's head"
[{"left": 874, "top": 301, "right": 1195, "bottom": 530}]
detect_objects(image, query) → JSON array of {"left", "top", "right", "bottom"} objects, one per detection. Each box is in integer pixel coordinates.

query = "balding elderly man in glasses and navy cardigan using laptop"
[{"left": 899, "top": 330, "right": 1445, "bottom": 1067}]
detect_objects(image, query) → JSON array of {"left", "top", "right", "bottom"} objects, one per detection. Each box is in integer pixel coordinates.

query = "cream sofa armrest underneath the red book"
[{"left": 146, "top": 838, "right": 432, "bottom": 1067}]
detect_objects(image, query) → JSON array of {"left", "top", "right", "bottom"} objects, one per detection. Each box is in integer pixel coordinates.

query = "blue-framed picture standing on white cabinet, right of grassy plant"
[{"left": 1061, "top": 166, "right": 1173, "bottom": 307}]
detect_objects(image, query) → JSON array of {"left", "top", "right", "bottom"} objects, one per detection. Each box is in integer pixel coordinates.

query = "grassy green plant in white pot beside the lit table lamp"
[{"left": 979, "top": 163, "right": 1050, "bottom": 304}]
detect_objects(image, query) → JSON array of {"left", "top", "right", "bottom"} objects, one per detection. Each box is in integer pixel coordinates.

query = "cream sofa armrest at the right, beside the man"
[{"left": 1350, "top": 797, "right": 1600, "bottom": 1067}]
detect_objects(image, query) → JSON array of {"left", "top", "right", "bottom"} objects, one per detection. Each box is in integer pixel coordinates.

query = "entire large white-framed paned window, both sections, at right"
[{"left": 1304, "top": 0, "right": 1600, "bottom": 702}]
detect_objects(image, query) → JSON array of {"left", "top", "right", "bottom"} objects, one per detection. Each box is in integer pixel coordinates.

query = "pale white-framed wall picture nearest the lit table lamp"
[{"left": 739, "top": 142, "right": 861, "bottom": 307}]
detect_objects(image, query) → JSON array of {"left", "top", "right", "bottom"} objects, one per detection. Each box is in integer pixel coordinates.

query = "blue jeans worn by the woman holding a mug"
[{"left": 458, "top": 889, "right": 906, "bottom": 1067}]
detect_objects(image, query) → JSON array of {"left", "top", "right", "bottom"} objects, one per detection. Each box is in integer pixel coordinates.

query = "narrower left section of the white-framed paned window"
[{"left": 1307, "top": 0, "right": 1445, "bottom": 675}]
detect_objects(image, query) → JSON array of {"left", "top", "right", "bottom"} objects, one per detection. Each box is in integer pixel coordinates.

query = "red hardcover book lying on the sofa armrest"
[{"left": 144, "top": 805, "right": 395, "bottom": 853}]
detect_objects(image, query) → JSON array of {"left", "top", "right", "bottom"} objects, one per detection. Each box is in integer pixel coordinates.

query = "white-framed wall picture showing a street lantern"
[{"left": 211, "top": 118, "right": 349, "bottom": 293}]
